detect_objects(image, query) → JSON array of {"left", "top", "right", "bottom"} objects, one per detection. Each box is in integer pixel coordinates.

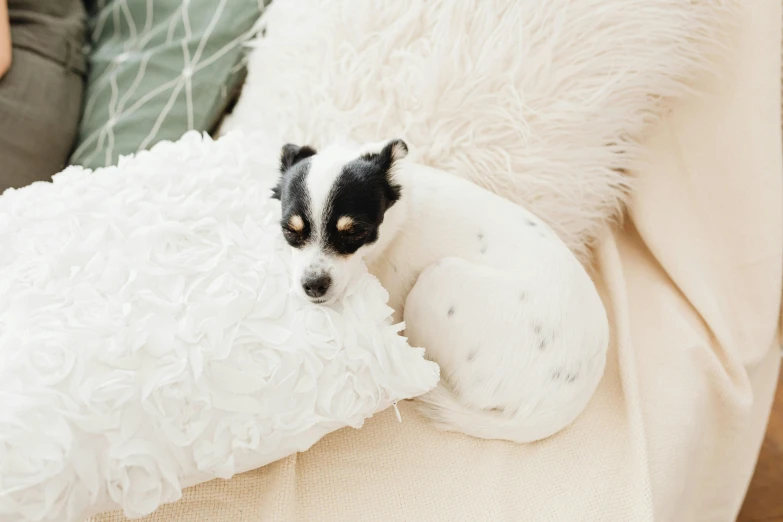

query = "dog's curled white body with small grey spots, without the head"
[{"left": 368, "top": 161, "right": 609, "bottom": 442}]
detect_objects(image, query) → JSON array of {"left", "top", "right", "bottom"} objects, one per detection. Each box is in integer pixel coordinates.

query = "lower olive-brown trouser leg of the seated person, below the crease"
[{"left": 0, "top": 48, "right": 84, "bottom": 193}]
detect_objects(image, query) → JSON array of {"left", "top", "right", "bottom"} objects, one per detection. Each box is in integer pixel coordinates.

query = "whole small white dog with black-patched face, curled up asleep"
[{"left": 272, "top": 140, "right": 609, "bottom": 442}]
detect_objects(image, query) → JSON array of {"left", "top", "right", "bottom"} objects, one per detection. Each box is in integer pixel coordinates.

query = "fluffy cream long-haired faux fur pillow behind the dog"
[{"left": 224, "top": 0, "right": 739, "bottom": 259}]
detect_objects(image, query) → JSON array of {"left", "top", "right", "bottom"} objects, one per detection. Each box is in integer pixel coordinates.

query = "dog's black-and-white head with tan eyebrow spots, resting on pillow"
[{"left": 272, "top": 140, "right": 408, "bottom": 303}]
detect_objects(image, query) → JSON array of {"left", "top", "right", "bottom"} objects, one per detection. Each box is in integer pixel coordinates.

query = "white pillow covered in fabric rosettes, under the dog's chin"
[{"left": 0, "top": 133, "right": 438, "bottom": 522}]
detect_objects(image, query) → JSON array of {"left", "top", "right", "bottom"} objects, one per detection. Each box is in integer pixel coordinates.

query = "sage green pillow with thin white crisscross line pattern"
[{"left": 71, "top": 0, "right": 270, "bottom": 168}]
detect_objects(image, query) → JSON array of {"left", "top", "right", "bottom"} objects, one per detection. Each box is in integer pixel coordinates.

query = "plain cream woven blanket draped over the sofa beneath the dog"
[{"left": 94, "top": 2, "right": 783, "bottom": 522}]
